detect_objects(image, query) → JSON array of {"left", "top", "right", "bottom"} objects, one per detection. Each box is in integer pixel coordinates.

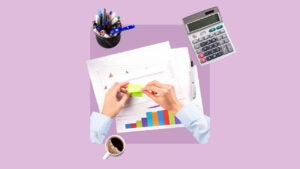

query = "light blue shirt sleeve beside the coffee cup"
[{"left": 90, "top": 112, "right": 112, "bottom": 144}]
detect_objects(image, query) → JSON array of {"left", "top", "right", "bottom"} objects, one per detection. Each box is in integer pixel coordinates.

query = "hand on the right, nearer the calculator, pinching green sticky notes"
[{"left": 143, "top": 81, "right": 183, "bottom": 114}]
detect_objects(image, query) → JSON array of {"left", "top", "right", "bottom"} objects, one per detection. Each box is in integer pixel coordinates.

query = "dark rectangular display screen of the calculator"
[{"left": 187, "top": 14, "right": 220, "bottom": 32}]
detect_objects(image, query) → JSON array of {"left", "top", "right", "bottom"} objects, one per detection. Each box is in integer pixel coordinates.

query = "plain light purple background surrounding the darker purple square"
[{"left": 0, "top": 0, "right": 300, "bottom": 169}]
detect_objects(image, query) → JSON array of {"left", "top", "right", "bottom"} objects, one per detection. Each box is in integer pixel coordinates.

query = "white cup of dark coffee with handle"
[{"left": 102, "top": 135, "right": 126, "bottom": 160}]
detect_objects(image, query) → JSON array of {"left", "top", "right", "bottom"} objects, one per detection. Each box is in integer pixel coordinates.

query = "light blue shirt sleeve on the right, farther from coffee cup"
[{"left": 176, "top": 103, "right": 210, "bottom": 144}]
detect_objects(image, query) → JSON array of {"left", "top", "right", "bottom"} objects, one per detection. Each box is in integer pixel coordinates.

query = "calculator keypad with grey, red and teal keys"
[{"left": 191, "top": 25, "right": 234, "bottom": 64}]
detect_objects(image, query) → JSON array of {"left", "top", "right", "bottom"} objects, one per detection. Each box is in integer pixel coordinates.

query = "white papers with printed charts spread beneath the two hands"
[{"left": 87, "top": 42, "right": 204, "bottom": 133}]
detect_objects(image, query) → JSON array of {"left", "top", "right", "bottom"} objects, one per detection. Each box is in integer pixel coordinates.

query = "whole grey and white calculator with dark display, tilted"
[{"left": 183, "top": 7, "right": 235, "bottom": 65}]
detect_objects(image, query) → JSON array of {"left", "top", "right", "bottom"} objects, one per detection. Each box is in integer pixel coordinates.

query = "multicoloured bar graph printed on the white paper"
[{"left": 125, "top": 110, "right": 181, "bottom": 129}]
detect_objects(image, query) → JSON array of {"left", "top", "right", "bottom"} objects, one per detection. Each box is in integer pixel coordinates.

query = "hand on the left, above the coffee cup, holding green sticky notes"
[{"left": 102, "top": 82, "right": 129, "bottom": 118}]
